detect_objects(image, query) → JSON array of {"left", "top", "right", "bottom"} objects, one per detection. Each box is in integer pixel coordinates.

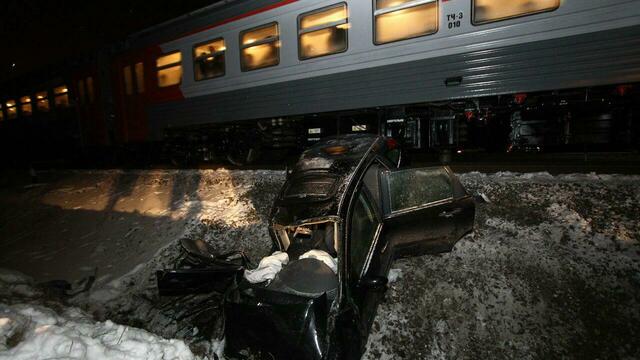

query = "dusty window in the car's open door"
[{"left": 388, "top": 168, "right": 453, "bottom": 212}]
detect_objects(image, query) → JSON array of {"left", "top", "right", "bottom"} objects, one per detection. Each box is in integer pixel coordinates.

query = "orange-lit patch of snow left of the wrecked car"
[{"left": 42, "top": 169, "right": 255, "bottom": 224}]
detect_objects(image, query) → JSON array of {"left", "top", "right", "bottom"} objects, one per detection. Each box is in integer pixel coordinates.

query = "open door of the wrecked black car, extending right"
[{"left": 380, "top": 166, "right": 475, "bottom": 256}]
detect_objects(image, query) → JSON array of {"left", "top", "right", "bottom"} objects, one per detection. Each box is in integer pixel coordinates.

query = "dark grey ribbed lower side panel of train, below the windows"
[{"left": 150, "top": 26, "right": 640, "bottom": 139}]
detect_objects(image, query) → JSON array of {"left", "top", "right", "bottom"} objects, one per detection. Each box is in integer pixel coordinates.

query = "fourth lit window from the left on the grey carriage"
[{"left": 298, "top": 3, "right": 349, "bottom": 60}]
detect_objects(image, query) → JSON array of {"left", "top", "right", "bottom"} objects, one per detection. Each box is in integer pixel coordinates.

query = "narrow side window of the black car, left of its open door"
[{"left": 349, "top": 189, "right": 378, "bottom": 280}]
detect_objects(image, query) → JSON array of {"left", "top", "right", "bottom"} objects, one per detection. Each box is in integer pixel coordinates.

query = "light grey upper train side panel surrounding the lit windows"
[{"left": 156, "top": 0, "right": 640, "bottom": 98}]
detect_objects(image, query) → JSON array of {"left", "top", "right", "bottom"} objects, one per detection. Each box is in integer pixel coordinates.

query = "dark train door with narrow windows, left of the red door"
[{"left": 72, "top": 68, "right": 108, "bottom": 148}]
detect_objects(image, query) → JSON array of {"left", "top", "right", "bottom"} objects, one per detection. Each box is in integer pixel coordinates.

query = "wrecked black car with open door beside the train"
[{"left": 224, "top": 135, "right": 475, "bottom": 359}]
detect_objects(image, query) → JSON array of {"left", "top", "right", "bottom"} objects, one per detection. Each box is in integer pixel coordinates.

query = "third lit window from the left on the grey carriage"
[{"left": 240, "top": 23, "right": 280, "bottom": 71}]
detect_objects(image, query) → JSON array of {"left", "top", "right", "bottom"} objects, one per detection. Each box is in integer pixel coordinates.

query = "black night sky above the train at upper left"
[{"left": 0, "top": 0, "right": 219, "bottom": 81}]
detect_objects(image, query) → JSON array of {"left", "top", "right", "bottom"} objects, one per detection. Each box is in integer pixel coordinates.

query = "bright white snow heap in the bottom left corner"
[{"left": 0, "top": 304, "right": 195, "bottom": 360}]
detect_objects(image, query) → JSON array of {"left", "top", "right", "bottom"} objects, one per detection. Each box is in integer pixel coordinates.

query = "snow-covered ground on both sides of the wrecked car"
[{"left": 0, "top": 170, "right": 640, "bottom": 359}]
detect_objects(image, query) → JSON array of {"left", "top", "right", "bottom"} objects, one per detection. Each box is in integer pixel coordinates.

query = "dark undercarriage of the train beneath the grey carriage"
[{"left": 164, "top": 84, "right": 640, "bottom": 166}]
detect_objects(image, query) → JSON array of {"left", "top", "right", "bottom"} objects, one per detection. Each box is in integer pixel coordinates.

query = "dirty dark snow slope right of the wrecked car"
[{"left": 365, "top": 173, "right": 640, "bottom": 359}]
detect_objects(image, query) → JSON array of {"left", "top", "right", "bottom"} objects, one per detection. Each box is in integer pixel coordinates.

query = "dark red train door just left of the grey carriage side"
[{"left": 115, "top": 56, "right": 148, "bottom": 143}]
